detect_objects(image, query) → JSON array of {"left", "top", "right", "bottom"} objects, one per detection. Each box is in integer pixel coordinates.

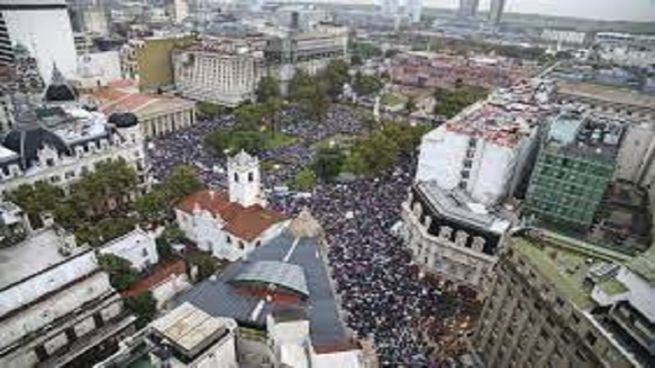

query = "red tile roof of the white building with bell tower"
[{"left": 177, "top": 190, "right": 286, "bottom": 241}]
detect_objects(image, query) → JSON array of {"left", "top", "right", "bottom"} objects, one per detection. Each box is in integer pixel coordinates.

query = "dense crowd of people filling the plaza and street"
[{"left": 150, "top": 105, "right": 476, "bottom": 367}]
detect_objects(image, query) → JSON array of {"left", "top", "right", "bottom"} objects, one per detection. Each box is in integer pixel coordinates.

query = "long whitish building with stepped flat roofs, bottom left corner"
[{"left": 0, "top": 217, "right": 136, "bottom": 367}]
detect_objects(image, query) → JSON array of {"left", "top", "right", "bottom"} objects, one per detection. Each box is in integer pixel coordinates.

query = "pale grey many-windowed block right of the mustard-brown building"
[{"left": 173, "top": 37, "right": 266, "bottom": 107}]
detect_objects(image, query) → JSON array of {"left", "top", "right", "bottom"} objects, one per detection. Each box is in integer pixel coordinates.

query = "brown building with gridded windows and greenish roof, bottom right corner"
[{"left": 472, "top": 231, "right": 655, "bottom": 368}]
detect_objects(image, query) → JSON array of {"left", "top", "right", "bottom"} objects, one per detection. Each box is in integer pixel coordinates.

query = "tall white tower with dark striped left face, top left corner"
[{"left": 0, "top": 0, "right": 77, "bottom": 80}]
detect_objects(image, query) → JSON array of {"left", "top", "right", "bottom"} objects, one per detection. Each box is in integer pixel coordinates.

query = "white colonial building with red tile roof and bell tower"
[{"left": 175, "top": 151, "right": 288, "bottom": 261}]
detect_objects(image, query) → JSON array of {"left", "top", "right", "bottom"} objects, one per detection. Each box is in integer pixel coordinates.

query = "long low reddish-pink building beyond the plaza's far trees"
[{"left": 389, "top": 51, "right": 532, "bottom": 89}]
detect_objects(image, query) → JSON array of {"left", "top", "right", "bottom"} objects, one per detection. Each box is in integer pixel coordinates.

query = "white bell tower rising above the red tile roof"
[{"left": 227, "top": 150, "right": 265, "bottom": 207}]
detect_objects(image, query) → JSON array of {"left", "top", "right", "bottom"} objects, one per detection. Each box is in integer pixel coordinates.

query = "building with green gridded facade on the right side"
[{"left": 524, "top": 112, "right": 623, "bottom": 231}]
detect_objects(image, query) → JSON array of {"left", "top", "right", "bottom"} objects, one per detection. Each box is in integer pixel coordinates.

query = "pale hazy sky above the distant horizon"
[{"left": 306, "top": 0, "right": 655, "bottom": 23}]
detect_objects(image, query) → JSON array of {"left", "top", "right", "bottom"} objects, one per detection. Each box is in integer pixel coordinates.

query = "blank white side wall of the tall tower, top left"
[{"left": 3, "top": 5, "right": 77, "bottom": 83}]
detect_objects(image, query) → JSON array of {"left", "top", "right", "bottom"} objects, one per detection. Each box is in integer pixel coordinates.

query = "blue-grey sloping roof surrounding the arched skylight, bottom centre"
[{"left": 175, "top": 232, "right": 350, "bottom": 347}]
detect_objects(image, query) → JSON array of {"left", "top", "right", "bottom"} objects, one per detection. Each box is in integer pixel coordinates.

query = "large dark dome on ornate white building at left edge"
[{"left": 1, "top": 126, "right": 70, "bottom": 169}]
